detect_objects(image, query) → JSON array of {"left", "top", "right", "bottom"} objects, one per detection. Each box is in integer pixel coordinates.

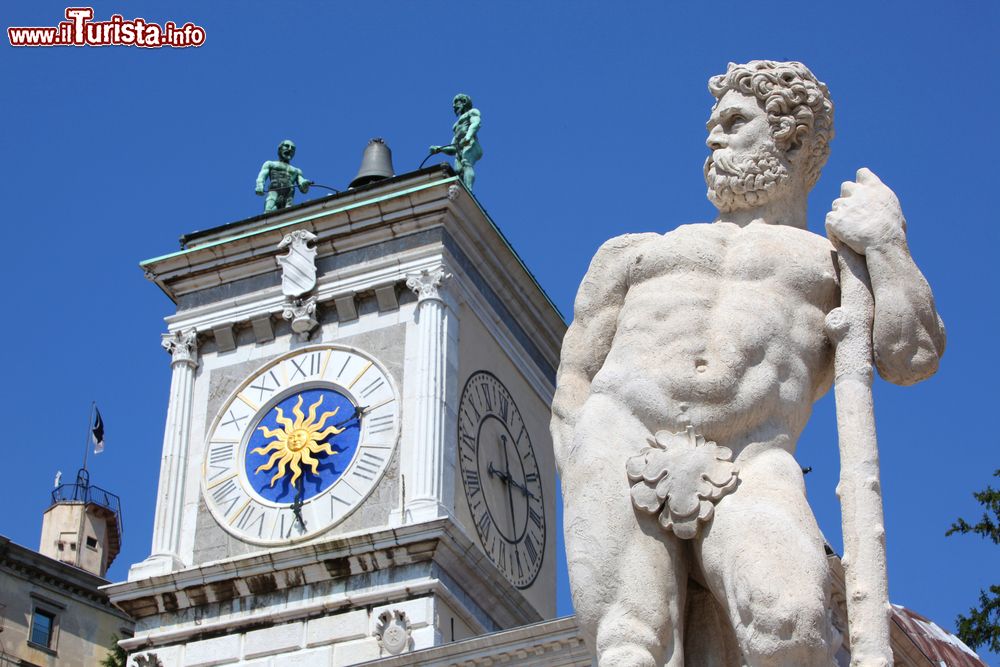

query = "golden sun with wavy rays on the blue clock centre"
[{"left": 253, "top": 394, "right": 344, "bottom": 487}]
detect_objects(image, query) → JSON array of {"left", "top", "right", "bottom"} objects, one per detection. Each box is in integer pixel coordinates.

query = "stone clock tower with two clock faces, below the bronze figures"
[{"left": 109, "top": 166, "right": 565, "bottom": 667}]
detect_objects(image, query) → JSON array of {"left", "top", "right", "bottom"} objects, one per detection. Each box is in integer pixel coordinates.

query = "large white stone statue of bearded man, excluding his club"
[{"left": 552, "top": 61, "right": 945, "bottom": 667}]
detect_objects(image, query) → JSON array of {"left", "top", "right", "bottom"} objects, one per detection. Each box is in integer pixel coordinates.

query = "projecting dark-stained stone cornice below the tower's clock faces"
[{"left": 104, "top": 519, "right": 539, "bottom": 646}]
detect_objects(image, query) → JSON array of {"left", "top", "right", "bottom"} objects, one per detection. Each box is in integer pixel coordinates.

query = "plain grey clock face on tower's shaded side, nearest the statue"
[{"left": 458, "top": 371, "right": 545, "bottom": 588}]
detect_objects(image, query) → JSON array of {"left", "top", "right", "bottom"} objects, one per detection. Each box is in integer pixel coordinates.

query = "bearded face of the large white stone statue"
[{"left": 705, "top": 90, "right": 790, "bottom": 212}]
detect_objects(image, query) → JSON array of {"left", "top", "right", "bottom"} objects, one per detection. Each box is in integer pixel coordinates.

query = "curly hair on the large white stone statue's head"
[{"left": 708, "top": 60, "right": 833, "bottom": 188}]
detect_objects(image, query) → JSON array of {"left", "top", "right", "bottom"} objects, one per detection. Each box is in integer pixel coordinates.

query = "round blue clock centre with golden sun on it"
[{"left": 244, "top": 388, "right": 361, "bottom": 503}]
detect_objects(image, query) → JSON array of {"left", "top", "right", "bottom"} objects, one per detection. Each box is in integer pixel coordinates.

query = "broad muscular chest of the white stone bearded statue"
[{"left": 629, "top": 223, "right": 837, "bottom": 307}]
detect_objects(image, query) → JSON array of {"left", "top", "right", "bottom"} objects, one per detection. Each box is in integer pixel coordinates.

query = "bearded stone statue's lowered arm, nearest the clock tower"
[{"left": 552, "top": 234, "right": 646, "bottom": 461}]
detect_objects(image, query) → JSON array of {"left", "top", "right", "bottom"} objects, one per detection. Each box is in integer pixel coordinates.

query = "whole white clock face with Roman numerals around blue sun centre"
[{"left": 202, "top": 346, "right": 399, "bottom": 544}]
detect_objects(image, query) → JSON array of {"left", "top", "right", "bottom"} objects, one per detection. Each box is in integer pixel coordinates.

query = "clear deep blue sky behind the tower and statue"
[{"left": 0, "top": 1, "right": 1000, "bottom": 660}]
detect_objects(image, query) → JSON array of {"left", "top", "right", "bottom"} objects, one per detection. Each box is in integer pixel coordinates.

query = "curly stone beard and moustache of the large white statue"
[{"left": 705, "top": 141, "right": 788, "bottom": 213}]
